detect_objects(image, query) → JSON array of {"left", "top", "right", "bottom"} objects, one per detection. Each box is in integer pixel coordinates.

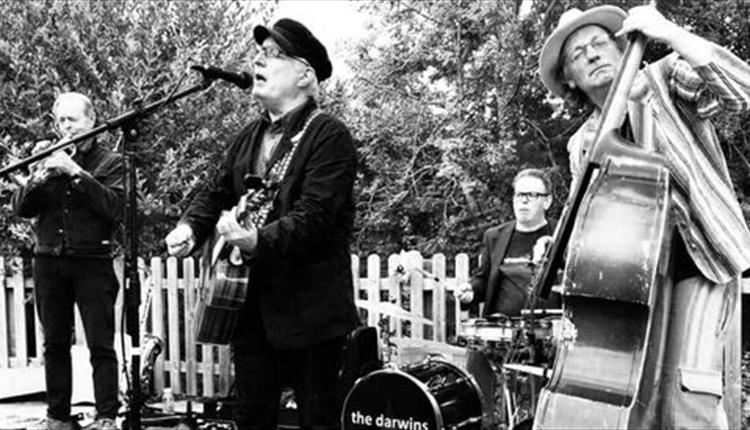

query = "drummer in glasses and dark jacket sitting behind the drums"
[{"left": 456, "top": 169, "right": 560, "bottom": 317}]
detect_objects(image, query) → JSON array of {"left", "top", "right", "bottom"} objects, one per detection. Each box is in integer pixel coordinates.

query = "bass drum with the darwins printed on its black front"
[{"left": 341, "top": 357, "right": 483, "bottom": 430}]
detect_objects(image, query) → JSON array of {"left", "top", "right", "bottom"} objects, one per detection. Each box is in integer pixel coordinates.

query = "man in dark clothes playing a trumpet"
[{"left": 12, "top": 92, "right": 125, "bottom": 429}]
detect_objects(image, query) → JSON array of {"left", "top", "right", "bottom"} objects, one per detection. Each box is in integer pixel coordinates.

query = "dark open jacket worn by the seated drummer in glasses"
[{"left": 464, "top": 220, "right": 559, "bottom": 316}]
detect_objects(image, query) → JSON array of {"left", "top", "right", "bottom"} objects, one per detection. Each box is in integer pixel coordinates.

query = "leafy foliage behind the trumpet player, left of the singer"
[{"left": 0, "top": 0, "right": 273, "bottom": 255}]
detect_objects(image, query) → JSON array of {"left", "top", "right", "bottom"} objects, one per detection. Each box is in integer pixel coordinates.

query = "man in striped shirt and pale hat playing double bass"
[{"left": 539, "top": 6, "right": 750, "bottom": 428}]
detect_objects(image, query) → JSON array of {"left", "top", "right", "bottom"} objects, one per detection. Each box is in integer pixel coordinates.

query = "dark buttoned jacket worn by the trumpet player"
[{"left": 12, "top": 142, "right": 125, "bottom": 257}]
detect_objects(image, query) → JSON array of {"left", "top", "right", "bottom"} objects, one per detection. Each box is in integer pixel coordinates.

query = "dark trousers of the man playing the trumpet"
[{"left": 34, "top": 256, "right": 119, "bottom": 420}]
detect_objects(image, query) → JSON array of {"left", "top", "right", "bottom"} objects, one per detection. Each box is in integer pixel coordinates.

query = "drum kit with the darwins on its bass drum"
[{"left": 341, "top": 305, "right": 562, "bottom": 430}]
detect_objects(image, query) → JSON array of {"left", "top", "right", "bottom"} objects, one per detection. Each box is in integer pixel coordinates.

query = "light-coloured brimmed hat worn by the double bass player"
[{"left": 539, "top": 6, "right": 628, "bottom": 96}]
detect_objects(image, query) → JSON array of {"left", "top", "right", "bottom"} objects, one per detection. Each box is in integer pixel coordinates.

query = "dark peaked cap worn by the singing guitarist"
[{"left": 253, "top": 18, "right": 333, "bottom": 82}]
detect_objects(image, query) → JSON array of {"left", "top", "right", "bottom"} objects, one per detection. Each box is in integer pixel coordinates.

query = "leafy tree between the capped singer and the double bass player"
[{"left": 348, "top": 1, "right": 531, "bottom": 253}]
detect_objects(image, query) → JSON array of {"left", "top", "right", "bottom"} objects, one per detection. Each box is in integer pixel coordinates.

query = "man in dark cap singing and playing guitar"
[{"left": 166, "top": 19, "right": 358, "bottom": 429}]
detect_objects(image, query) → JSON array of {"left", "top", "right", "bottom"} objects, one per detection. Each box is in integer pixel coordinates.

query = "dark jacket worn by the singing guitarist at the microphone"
[{"left": 181, "top": 100, "right": 358, "bottom": 348}]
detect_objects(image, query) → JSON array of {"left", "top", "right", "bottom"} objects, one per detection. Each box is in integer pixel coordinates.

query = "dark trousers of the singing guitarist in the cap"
[{"left": 232, "top": 314, "right": 344, "bottom": 430}]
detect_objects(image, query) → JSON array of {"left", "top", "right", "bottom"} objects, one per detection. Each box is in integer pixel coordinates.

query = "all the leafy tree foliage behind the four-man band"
[{"left": 0, "top": 0, "right": 750, "bottom": 262}]
